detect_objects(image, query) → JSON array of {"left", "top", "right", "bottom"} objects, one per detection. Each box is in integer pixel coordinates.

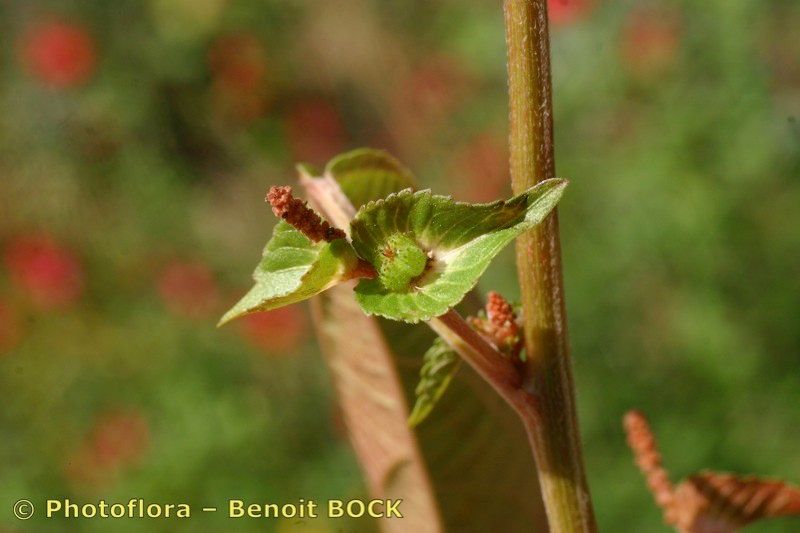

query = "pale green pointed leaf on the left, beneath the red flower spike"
[{"left": 219, "top": 220, "right": 358, "bottom": 325}]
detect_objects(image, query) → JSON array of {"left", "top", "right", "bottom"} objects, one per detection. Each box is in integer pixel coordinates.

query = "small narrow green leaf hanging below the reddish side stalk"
[{"left": 408, "top": 337, "right": 461, "bottom": 427}]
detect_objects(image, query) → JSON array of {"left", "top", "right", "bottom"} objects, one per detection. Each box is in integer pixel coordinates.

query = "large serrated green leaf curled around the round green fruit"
[{"left": 351, "top": 179, "right": 567, "bottom": 323}]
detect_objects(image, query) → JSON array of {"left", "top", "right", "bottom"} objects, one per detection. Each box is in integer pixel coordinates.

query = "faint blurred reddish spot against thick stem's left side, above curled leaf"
[{"left": 449, "top": 133, "right": 509, "bottom": 202}]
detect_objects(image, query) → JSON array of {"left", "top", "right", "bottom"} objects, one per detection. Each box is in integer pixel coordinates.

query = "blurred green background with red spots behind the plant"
[{"left": 0, "top": 0, "right": 800, "bottom": 531}]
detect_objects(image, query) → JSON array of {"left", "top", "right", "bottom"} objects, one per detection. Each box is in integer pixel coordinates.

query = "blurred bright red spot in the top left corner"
[{"left": 21, "top": 21, "right": 97, "bottom": 89}]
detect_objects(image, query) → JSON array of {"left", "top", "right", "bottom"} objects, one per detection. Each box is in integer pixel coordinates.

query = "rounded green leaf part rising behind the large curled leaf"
[{"left": 325, "top": 148, "right": 415, "bottom": 208}]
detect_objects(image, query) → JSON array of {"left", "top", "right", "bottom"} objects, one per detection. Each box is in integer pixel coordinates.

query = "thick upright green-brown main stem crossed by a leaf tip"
[{"left": 504, "top": 0, "right": 597, "bottom": 532}]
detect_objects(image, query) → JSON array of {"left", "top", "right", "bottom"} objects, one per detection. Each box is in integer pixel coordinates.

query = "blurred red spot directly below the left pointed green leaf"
[{"left": 242, "top": 305, "right": 306, "bottom": 355}]
